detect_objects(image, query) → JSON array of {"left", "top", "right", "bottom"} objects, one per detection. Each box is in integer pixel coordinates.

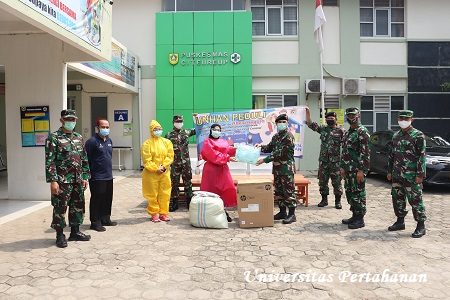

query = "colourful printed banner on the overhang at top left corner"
[{"left": 20, "top": 0, "right": 105, "bottom": 50}]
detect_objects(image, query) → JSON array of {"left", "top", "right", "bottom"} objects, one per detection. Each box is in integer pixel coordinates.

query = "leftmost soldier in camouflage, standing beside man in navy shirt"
[{"left": 45, "top": 109, "right": 91, "bottom": 248}]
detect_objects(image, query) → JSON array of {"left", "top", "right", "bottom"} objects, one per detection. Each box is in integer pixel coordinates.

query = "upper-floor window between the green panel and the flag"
[{"left": 251, "top": 0, "right": 298, "bottom": 36}]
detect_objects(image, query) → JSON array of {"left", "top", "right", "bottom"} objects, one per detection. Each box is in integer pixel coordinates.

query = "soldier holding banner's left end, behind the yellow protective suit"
[{"left": 166, "top": 116, "right": 195, "bottom": 212}]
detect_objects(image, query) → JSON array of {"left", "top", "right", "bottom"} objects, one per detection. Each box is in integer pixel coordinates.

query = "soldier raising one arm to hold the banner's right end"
[{"left": 306, "top": 108, "right": 345, "bottom": 209}]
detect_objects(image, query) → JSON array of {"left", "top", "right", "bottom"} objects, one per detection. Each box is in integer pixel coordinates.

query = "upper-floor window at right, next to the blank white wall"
[{"left": 359, "top": 0, "right": 405, "bottom": 37}]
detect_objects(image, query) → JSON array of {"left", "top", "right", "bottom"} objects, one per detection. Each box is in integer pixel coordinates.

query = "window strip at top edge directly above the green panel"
[{"left": 163, "top": 0, "right": 245, "bottom": 11}]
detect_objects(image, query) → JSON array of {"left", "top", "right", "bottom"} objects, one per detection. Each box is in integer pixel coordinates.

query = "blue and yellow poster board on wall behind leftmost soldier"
[{"left": 20, "top": 106, "right": 50, "bottom": 147}]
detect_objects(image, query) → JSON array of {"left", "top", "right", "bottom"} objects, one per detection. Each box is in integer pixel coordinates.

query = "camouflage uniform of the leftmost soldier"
[{"left": 45, "top": 128, "right": 90, "bottom": 230}]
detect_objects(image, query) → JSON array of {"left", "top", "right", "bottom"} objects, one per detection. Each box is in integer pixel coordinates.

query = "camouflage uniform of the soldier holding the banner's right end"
[{"left": 308, "top": 122, "right": 345, "bottom": 197}]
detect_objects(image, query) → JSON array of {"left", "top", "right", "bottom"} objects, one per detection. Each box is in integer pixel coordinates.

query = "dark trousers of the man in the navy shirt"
[{"left": 89, "top": 179, "right": 113, "bottom": 223}]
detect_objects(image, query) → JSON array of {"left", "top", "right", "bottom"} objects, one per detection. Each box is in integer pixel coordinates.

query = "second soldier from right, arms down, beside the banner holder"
[{"left": 340, "top": 107, "right": 370, "bottom": 229}]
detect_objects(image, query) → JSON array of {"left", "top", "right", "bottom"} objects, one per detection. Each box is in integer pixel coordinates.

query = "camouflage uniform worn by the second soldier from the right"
[{"left": 340, "top": 116, "right": 370, "bottom": 216}]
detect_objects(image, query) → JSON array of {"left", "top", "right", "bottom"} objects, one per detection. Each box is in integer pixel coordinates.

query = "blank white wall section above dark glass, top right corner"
[{"left": 405, "top": 0, "right": 450, "bottom": 40}]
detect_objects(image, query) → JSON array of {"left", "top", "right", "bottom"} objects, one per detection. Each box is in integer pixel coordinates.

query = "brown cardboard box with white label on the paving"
[{"left": 237, "top": 181, "right": 273, "bottom": 228}]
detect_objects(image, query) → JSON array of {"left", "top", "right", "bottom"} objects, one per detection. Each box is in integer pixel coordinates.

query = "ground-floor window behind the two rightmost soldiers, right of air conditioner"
[{"left": 361, "top": 96, "right": 406, "bottom": 133}]
